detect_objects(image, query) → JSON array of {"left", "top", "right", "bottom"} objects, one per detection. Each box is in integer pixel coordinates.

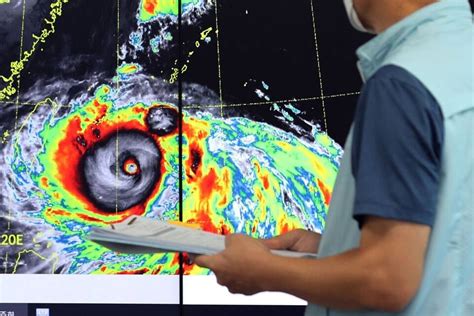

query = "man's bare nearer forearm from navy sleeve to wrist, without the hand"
[{"left": 262, "top": 217, "right": 430, "bottom": 311}]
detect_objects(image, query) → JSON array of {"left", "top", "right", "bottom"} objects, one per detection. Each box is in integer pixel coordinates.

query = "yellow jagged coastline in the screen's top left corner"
[{"left": 0, "top": 0, "right": 69, "bottom": 101}]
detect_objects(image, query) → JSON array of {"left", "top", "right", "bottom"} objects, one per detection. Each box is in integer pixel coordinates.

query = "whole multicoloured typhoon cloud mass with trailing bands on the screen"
[{"left": 0, "top": 0, "right": 342, "bottom": 274}]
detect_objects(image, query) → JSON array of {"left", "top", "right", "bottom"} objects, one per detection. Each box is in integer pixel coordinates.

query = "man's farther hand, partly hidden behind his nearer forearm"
[{"left": 261, "top": 229, "right": 321, "bottom": 253}]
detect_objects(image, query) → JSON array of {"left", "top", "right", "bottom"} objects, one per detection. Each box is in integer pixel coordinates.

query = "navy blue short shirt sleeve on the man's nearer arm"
[{"left": 351, "top": 66, "right": 444, "bottom": 226}]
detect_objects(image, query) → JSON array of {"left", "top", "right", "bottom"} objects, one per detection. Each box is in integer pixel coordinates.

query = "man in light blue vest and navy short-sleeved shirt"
[{"left": 196, "top": 0, "right": 474, "bottom": 316}]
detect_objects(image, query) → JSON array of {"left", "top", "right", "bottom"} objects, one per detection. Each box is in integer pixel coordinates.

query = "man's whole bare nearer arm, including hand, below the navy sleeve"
[{"left": 196, "top": 217, "right": 430, "bottom": 312}]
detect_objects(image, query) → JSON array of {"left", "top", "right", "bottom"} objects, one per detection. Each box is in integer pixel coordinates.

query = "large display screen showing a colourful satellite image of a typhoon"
[{"left": 0, "top": 0, "right": 370, "bottom": 305}]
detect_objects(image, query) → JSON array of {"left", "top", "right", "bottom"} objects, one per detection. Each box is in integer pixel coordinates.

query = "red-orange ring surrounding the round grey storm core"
[{"left": 54, "top": 100, "right": 170, "bottom": 223}]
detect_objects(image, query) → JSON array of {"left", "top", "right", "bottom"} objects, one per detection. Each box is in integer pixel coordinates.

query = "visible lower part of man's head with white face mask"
[{"left": 344, "top": 0, "right": 438, "bottom": 33}]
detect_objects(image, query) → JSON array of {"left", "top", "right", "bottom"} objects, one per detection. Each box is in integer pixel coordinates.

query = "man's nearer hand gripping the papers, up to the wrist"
[{"left": 195, "top": 235, "right": 273, "bottom": 295}]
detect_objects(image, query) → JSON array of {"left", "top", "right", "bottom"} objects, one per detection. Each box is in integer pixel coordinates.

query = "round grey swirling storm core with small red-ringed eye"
[{"left": 81, "top": 131, "right": 161, "bottom": 212}]
